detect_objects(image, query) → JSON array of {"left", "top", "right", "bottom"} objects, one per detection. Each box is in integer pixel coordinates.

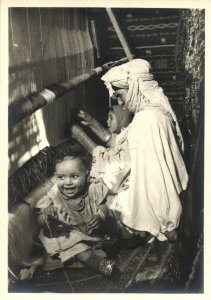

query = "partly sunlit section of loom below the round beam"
[{"left": 9, "top": 77, "right": 108, "bottom": 174}]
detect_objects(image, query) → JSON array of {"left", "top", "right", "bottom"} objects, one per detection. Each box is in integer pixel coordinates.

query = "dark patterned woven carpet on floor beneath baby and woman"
[{"left": 9, "top": 241, "right": 182, "bottom": 293}]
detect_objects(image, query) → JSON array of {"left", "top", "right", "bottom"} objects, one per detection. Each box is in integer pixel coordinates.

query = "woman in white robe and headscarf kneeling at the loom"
[{"left": 71, "top": 59, "right": 188, "bottom": 241}]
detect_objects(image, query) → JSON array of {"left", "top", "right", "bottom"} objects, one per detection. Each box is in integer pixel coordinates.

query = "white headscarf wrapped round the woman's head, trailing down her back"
[{"left": 101, "top": 58, "right": 184, "bottom": 151}]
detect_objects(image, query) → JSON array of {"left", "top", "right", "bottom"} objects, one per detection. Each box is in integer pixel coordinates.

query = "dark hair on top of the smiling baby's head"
[{"left": 53, "top": 145, "right": 92, "bottom": 170}]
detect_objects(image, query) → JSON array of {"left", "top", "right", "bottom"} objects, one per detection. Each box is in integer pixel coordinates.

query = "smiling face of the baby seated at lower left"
[{"left": 55, "top": 157, "right": 88, "bottom": 199}]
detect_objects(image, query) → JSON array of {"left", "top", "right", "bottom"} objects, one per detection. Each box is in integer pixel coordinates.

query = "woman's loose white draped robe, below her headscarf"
[{"left": 90, "top": 106, "right": 188, "bottom": 240}]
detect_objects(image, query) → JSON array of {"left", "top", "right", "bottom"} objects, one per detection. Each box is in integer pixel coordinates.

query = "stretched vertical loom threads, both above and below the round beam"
[{"left": 9, "top": 7, "right": 96, "bottom": 173}]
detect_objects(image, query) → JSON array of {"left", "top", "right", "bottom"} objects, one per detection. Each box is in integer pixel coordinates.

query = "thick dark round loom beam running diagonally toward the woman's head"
[{"left": 9, "top": 58, "right": 128, "bottom": 126}]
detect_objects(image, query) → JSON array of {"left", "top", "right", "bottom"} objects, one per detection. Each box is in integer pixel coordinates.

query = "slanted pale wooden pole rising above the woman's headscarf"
[{"left": 106, "top": 8, "right": 133, "bottom": 60}]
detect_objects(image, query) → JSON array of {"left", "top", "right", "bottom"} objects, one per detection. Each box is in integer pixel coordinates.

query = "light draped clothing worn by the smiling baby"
[{"left": 36, "top": 182, "right": 108, "bottom": 262}]
